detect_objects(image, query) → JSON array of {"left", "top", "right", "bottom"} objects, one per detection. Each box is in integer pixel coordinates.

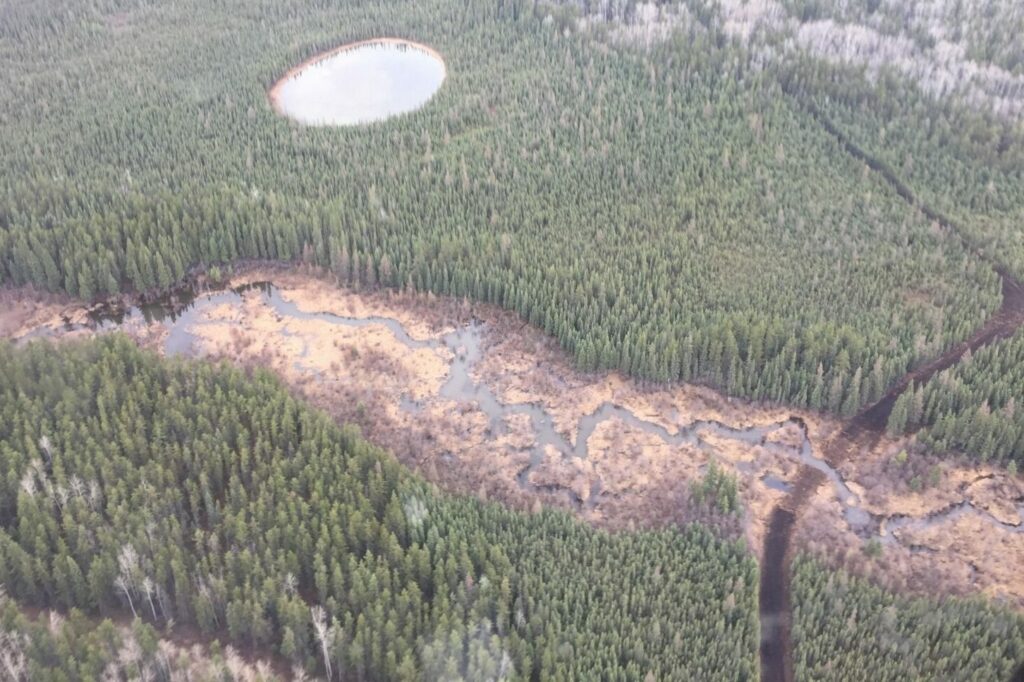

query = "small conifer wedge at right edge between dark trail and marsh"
[{"left": 889, "top": 331, "right": 1024, "bottom": 464}]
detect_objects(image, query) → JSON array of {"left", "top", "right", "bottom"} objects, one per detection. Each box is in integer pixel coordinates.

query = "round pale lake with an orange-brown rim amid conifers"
[{"left": 270, "top": 38, "right": 445, "bottom": 126}]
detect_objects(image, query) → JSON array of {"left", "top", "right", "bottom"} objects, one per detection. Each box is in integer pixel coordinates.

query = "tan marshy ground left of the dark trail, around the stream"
[{"left": 146, "top": 269, "right": 818, "bottom": 548}]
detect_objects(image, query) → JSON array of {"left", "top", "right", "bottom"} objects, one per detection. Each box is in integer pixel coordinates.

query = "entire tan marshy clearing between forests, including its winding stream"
[{"left": 13, "top": 266, "right": 1024, "bottom": 608}]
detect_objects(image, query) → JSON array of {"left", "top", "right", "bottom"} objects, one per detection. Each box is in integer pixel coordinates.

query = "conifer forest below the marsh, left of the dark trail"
[{"left": 0, "top": 337, "right": 759, "bottom": 680}]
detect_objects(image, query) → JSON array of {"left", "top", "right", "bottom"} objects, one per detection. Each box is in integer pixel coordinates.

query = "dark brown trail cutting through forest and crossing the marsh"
[{"left": 759, "top": 91, "right": 1024, "bottom": 682}]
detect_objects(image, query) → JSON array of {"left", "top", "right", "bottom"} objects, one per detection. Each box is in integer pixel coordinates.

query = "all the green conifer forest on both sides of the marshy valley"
[{"left": 6, "top": 0, "right": 1024, "bottom": 682}]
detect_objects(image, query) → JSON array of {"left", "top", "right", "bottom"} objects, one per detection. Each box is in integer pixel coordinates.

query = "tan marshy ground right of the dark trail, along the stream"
[{"left": 796, "top": 439, "right": 1024, "bottom": 608}]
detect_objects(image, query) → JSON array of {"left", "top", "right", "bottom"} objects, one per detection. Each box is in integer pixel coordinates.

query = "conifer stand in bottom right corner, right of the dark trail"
[{"left": 792, "top": 556, "right": 1024, "bottom": 682}]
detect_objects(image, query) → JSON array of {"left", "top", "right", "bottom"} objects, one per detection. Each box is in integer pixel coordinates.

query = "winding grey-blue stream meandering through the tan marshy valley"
[{"left": 29, "top": 282, "right": 1024, "bottom": 542}]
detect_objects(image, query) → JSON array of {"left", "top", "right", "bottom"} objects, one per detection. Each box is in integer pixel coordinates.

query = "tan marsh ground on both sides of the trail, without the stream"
[{"left": 8, "top": 268, "right": 1024, "bottom": 606}]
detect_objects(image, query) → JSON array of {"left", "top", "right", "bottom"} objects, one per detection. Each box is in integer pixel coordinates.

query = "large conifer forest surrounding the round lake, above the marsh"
[{"left": 0, "top": 0, "right": 999, "bottom": 415}]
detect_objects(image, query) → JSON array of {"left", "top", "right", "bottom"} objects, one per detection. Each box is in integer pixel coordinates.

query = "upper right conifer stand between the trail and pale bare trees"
[{"left": 786, "top": 60, "right": 1024, "bottom": 280}]
